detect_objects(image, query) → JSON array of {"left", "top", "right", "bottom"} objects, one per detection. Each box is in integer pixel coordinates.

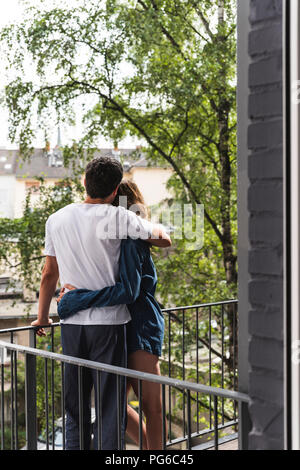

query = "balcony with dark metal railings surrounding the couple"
[{"left": 0, "top": 300, "right": 248, "bottom": 450}]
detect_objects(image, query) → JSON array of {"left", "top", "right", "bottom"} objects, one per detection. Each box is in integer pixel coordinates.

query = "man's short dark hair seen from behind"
[{"left": 85, "top": 157, "right": 123, "bottom": 199}]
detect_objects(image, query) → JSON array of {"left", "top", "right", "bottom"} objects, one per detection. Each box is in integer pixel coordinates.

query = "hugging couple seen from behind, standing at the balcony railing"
[{"left": 32, "top": 157, "right": 171, "bottom": 450}]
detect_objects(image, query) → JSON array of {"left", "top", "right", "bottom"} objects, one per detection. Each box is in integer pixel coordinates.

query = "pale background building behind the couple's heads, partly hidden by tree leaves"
[{"left": 0, "top": 149, "right": 172, "bottom": 218}]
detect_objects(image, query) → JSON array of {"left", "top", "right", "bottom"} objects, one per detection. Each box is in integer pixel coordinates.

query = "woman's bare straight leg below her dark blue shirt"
[{"left": 128, "top": 351, "right": 162, "bottom": 450}]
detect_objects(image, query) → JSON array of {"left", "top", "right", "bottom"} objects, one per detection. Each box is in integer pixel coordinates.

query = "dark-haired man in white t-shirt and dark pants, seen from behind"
[{"left": 32, "top": 157, "right": 171, "bottom": 450}]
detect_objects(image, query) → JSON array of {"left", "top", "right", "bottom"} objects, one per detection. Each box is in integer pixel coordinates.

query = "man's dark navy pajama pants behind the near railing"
[{"left": 61, "top": 324, "right": 127, "bottom": 450}]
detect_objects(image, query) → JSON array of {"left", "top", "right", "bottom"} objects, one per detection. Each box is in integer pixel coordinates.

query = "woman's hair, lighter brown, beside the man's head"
[{"left": 113, "top": 179, "right": 148, "bottom": 218}]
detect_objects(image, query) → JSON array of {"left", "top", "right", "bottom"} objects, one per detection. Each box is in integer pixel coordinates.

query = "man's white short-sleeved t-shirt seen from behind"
[{"left": 44, "top": 203, "right": 153, "bottom": 325}]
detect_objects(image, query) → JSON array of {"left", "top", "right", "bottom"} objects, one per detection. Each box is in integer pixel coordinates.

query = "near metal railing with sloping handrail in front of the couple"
[{"left": 0, "top": 341, "right": 248, "bottom": 450}]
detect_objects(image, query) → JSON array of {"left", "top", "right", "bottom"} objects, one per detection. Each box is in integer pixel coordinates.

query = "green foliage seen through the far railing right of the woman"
[{"left": 160, "top": 306, "right": 237, "bottom": 429}]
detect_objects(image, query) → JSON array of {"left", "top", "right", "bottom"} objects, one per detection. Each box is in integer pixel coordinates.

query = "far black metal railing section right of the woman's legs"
[{"left": 161, "top": 300, "right": 238, "bottom": 432}]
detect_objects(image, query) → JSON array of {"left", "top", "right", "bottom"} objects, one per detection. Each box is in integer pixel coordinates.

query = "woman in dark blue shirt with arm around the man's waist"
[{"left": 58, "top": 180, "right": 164, "bottom": 450}]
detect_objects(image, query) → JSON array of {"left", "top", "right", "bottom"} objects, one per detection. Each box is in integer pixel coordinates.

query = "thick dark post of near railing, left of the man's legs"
[{"left": 25, "top": 354, "right": 37, "bottom": 450}]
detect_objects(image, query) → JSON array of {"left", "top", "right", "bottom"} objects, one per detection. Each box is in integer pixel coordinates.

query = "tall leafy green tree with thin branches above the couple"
[{"left": 2, "top": 0, "right": 237, "bottom": 303}]
